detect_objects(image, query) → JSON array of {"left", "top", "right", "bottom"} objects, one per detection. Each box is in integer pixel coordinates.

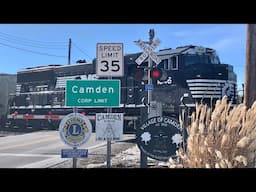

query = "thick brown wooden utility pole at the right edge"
[{"left": 244, "top": 24, "right": 256, "bottom": 108}]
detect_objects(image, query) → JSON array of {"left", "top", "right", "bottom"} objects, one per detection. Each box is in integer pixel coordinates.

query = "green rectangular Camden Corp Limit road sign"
[{"left": 65, "top": 80, "right": 120, "bottom": 107}]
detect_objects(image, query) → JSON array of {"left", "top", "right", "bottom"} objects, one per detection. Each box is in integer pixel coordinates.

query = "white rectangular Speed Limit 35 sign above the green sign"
[{"left": 96, "top": 43, "right": 124, "bottom": 77}]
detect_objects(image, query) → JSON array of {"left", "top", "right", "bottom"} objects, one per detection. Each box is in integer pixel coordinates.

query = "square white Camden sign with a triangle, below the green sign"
[{"left": 96, "top": 113, "right": 124, "bottom": 141}]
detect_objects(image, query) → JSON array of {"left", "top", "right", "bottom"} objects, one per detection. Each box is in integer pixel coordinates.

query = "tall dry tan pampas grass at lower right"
[{"left": 169, "top": 97, "right": 256, "bottom": 168}]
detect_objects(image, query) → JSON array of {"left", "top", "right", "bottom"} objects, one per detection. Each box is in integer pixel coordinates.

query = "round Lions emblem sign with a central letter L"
[{"left": 59, "top": 113, "right": 92, "bottom": 147}]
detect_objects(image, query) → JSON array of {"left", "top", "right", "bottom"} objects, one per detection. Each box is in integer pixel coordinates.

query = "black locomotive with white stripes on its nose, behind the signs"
[{"left": 1, "top": 45, "right": 237, "bottom": 132}]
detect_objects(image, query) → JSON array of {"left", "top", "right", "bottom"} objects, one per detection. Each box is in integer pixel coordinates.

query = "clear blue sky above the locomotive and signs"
[{"left": 0, "top": 24, "right": 246, "bottom": 88}]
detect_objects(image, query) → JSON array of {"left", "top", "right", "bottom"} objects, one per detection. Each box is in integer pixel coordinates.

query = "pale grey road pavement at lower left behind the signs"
[{"left": 0, "top": 131, "right": 133, "bottom": 168}]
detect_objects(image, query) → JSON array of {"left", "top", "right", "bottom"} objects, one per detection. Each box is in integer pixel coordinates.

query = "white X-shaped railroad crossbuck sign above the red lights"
[{"left": 135, "top": 39, "right": 161, "bottom": 65}]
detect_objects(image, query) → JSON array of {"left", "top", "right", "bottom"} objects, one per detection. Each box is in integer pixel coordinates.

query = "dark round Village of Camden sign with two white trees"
[{"left": 136, "top": 116, "right": 184, "bottom": 161}]
